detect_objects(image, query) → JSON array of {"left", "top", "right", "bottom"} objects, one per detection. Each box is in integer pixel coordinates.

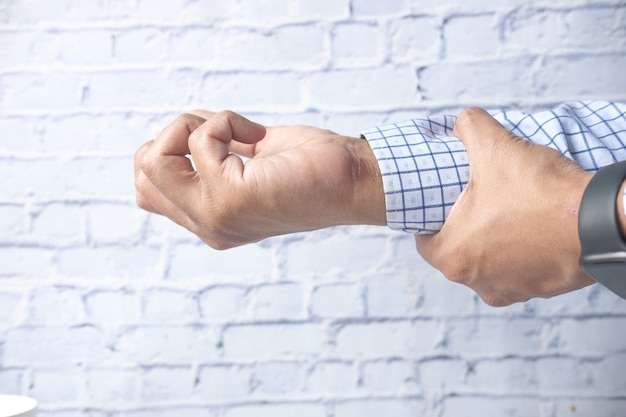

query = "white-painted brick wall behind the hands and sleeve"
[{"left": 0, "top": 0, "right": 626, "bottom": 417}]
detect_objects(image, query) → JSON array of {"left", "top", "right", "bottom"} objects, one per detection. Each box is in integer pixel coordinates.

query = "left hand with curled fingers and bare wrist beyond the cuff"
[{"left": 135, "top": 111, "right": 386, "bottom": 249}]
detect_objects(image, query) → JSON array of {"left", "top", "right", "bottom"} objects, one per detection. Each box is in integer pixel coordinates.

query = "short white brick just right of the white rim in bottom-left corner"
[{"left": 28, "top": 368, "right": 85, "bottom": 404}]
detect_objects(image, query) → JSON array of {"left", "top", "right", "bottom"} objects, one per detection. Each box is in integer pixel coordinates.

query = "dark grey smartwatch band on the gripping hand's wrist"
[{"left": 578, "top": 161, "right": 626, "bottom": 298}]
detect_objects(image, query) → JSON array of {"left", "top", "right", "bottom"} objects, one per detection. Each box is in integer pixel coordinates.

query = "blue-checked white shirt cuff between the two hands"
[{"left": 362, "top": 116, "right": 469, "bottom": 233}]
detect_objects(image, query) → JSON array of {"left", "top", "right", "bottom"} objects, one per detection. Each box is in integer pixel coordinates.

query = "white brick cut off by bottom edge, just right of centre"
[{"left": 335, "top": 399, "right": 425, "bottom": 417}]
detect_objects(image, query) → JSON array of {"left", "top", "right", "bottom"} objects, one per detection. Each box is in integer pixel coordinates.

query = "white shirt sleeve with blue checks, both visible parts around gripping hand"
[{"left": 362, "top": 101, "right": 626, "bottom": 233}]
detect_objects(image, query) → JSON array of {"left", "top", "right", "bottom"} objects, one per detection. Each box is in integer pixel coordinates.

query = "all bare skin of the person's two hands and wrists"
[{"left": 135, "top": 108, "right": 626, "bottom": 306}]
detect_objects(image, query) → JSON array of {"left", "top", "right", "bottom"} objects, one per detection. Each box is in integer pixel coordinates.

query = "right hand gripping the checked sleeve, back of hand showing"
[{"left": 416, "top": 109, "right": 594, "bottom": 306}]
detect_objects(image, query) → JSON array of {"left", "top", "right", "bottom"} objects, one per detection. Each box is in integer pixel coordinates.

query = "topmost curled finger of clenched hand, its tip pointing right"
[{"left": 189, "top": 111, "right": 266, "bottom": 175}]
